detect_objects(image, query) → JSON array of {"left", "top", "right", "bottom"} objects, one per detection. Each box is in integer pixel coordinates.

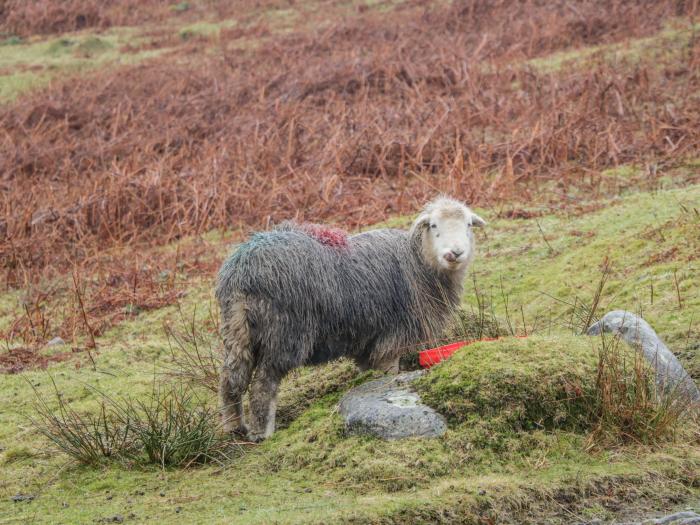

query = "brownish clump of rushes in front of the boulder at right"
[{"left": 588, "top": 336, "right": 697, "bottom": 448}]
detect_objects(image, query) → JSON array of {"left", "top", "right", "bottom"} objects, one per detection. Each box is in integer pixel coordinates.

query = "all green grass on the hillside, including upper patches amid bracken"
[{"left": 0, "top": 2, "right": 700, "bottom": 524}]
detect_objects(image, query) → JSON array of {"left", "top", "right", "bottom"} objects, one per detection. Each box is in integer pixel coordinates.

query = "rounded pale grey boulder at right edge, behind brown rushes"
[{"left": 586, "top": 310, "right": 700, "bottom": 403}]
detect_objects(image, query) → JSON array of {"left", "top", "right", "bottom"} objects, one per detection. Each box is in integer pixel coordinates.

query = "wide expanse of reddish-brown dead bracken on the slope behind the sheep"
[{"left": 0, "top": 0, "right": 700, "bottom": 364}]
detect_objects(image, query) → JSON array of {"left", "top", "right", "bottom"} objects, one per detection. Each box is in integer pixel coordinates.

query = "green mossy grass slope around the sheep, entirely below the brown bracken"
[{"left": 0, "top": 181, "right": 700, "bottom": 523}]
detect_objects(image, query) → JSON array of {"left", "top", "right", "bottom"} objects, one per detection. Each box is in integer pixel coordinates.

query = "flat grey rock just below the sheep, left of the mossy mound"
[{"left": 339, "top": 370, "right": 447, "bottom": 439}]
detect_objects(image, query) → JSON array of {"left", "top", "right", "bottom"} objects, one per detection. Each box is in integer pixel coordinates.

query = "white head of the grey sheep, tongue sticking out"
[{"left": 416, "top": 201, "right": 486, "bottom": 272}]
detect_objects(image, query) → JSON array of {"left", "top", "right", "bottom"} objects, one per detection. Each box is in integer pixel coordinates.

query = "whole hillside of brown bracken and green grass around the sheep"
[{"left": 0, "top": 0, "right": 700, "bottom": 525}]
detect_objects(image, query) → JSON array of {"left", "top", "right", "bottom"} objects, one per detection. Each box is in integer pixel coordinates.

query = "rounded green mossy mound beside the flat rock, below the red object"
[{"left": 417, "top": 335, "right": 598, "bottom": 433}]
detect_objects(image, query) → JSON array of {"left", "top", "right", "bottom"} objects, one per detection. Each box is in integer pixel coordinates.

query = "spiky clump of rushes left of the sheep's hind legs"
[{"left": 31, "top": 376, "right": 231, "bottom": 468}]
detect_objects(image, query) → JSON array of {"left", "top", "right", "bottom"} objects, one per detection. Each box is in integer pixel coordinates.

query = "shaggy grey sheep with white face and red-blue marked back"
[{"left": 216, "top": 197, "right": 486, "bottom": 441}]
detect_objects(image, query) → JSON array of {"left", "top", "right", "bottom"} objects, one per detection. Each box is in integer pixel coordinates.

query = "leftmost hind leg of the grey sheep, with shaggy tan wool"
[{"left": 219, "top": 303, "right": 255, "bottom": 436}]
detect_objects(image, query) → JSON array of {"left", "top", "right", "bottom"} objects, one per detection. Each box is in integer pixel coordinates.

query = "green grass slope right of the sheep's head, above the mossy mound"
[{"left": 465, "top": 185, "right": 700, "bottom": 366}]
